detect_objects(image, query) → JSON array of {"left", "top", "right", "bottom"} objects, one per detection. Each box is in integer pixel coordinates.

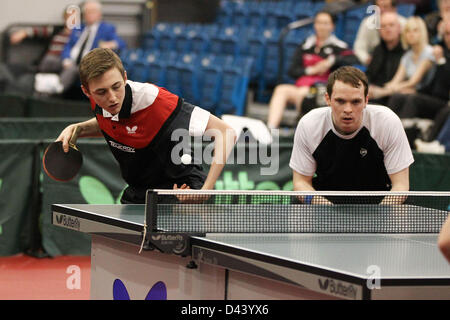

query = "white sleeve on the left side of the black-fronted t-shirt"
[{"left": 289, "top": 118, "right": 316, "bottom": 177}]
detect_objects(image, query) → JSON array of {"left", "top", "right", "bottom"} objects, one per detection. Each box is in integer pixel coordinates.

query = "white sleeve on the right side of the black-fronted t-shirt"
[{"left": 383, "top": 113, "right": 414, "bottom": 174}]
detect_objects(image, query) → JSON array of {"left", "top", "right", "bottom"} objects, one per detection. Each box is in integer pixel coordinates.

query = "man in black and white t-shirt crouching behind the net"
[{"left": 289, "top": 67, "right": 414, "bottom": 191}]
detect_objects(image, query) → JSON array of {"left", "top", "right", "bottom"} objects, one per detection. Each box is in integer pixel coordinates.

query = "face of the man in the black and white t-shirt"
[{"left": 325, "top": 80, "right": 368, "bottom": 135}]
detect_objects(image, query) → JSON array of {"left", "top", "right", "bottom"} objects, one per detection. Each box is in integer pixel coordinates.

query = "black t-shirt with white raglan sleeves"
[{"left": 289, "top": 105, "right": 414, "bottom": 191}]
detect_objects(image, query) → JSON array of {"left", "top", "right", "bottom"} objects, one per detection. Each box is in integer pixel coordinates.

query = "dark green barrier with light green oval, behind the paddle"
[{"left": 41, "top": 139, "right": 126, "bottom": 256}]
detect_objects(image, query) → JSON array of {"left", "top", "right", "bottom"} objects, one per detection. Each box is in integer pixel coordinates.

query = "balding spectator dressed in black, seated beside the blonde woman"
[{"left": 366, "top": 11, "right": 405, "bottom": 105}]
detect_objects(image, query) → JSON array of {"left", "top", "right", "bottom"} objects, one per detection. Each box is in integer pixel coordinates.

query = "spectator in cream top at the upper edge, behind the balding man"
[{"left": 353, "top": 0, "right": 406, "bottom": 66}]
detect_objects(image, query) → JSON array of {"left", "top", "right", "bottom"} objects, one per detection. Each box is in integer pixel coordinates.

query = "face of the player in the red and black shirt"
[{"left": 82, "top": 68, "right": 127, "bottom": 115}]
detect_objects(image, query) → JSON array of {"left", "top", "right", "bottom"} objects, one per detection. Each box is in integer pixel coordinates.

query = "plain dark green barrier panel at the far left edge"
[{"left": 0, "top": 140, "right": 39, "bottom": 256}]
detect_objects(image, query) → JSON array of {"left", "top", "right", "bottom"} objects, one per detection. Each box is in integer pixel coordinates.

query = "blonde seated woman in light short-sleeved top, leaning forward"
[{"left": 374, "top": 17, "right": 435, "bottom": 104}]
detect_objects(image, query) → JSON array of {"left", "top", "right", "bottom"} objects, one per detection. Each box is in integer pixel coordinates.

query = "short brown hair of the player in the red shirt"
[{"left": 78, "top": 48, "right": 125, "bottom": 90}]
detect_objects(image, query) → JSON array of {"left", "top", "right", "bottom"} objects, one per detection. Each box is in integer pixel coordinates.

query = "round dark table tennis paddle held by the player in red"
[{"left": 42, "top": 126, "right": 83, "bottom": 181}]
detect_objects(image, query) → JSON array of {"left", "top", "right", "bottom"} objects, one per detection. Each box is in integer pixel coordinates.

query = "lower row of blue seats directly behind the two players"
[{"left": 121, "top": 48, "right": 253, "bottom": 115}]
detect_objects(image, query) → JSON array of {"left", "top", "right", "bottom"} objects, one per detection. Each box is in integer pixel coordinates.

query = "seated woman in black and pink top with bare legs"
[{"left": 267, "top": 11, "right": 358, "bottom": 128}]
